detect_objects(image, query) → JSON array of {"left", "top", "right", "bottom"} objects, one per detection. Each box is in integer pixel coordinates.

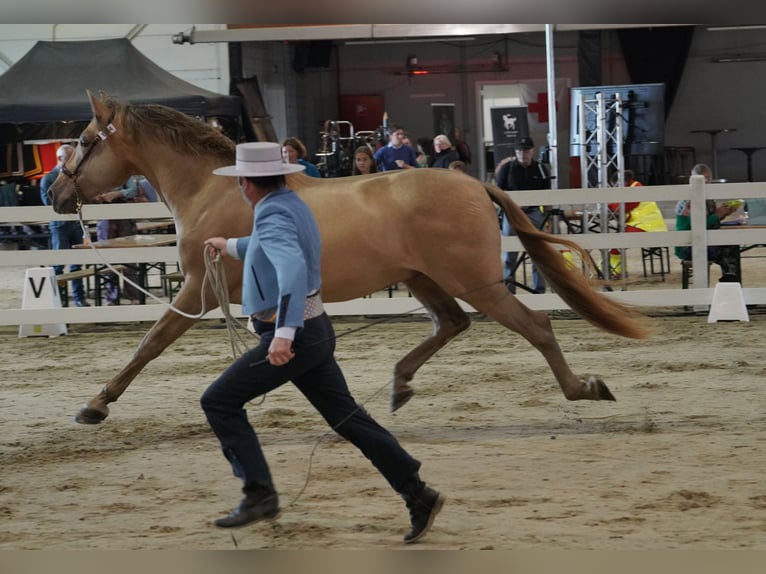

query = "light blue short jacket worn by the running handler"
[{"left": 226, "top": 187, "right": 321, "bottom": 329}]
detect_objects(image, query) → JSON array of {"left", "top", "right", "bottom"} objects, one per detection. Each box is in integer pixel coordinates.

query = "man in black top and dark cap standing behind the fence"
[{"left": 495, "top": 137, "right": 551, "bottom": 293}]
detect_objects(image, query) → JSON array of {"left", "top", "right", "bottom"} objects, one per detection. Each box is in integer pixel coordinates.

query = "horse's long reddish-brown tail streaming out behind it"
[{"left": 484, "top": 183, "right": 649, "bottom": 339}]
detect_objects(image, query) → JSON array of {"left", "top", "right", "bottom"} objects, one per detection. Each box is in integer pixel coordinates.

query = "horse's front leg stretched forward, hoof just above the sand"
[{"left": 75, "top": 278, "right": 213, "bottom": 424}]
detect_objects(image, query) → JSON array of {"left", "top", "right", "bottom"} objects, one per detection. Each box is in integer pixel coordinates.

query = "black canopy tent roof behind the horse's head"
[{"left": 0, "top": 38, "right": 242, "bottom": 143}]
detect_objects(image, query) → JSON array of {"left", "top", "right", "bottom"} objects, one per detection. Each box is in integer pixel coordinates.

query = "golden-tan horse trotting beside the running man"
[{"left": 51, "top": 93, "right": 648, "bottom": 423}]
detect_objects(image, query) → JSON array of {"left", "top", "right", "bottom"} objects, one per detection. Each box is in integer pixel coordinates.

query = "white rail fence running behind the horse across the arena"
[{"left": 0, "top": 176, "right": 766, "bottom": 325}]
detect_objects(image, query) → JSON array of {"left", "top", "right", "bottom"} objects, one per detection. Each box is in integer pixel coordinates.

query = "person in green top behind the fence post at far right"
[{"left": 675, "top": 163, "right": 739, "bottom": 283}]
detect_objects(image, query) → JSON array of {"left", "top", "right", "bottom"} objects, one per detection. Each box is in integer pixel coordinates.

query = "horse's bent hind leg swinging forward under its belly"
[{"left": 391, "top": 275, "right": 471, "bottom": 412}]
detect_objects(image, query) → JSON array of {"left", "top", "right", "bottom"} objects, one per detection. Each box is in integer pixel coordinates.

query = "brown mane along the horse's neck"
[{"left": 104, "top": 97, "right": 235, "bottom": 164}]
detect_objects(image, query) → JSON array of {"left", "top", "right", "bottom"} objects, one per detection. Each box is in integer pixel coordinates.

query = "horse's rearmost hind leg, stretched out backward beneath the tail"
[{"left": 466, "top": 285, "right": 615, "bottom": 401}]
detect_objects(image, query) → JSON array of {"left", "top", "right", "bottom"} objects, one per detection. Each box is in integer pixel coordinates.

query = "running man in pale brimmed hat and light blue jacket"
[{"left": 201, "top": 142, "right": 445, "bottom": 543}]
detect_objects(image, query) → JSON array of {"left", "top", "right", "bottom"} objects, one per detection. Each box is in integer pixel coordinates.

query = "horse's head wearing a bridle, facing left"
[{"left": 49, "top": 91, "right": 132, "bottom": 213}]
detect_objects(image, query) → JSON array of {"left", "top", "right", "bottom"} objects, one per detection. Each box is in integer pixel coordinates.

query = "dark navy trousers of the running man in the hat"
[{"left": 200, "top": 314, "right": 420, "bottom": 492}]
